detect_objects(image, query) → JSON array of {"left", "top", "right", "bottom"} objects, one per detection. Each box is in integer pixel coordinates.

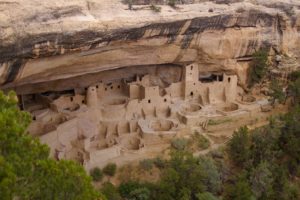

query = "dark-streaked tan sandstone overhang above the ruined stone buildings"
[{"left": 0, "top": 0, "right": 300, "bottom": 94}]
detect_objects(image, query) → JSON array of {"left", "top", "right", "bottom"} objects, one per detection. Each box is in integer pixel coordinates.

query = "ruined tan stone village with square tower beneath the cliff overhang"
[{"left": 15, "top": 63, "right": 274, "bottom": 169}]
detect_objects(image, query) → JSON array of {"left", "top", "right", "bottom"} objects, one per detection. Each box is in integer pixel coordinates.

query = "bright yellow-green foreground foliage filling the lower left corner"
[{"left": 0, "top": 92, "right": 98, "bottom": 200}]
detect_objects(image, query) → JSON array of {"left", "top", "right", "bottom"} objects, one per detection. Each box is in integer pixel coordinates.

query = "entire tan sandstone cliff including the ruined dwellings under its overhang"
[{"left": 0, "top": 0, "right": 300, "bottom": 170}]
